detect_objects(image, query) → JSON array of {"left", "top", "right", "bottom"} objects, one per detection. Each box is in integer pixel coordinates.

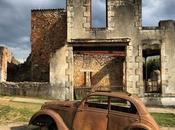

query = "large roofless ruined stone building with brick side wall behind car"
[{"left": 0, "top": 0, "right": 175, "bottom": 105}]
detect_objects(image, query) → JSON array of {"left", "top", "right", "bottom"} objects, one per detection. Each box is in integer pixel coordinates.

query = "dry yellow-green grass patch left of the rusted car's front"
[{"left": 0, "top": 102, "right": 41, "bottom": 124}]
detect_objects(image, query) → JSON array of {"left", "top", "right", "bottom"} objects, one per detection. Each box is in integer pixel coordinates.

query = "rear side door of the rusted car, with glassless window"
[{"left": 108, "top": 97, "right": 139, "bottom": 130}]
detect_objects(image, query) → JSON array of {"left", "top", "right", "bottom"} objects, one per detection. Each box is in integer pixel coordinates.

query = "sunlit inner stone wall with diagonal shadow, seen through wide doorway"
[{"left": 74, "top": 54, "right": 124, "bottom": 89}]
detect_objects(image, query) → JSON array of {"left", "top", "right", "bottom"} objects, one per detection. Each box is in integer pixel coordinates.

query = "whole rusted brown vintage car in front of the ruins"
[{"left": 29, "top": 92, "right": 160, "bottom": 130}]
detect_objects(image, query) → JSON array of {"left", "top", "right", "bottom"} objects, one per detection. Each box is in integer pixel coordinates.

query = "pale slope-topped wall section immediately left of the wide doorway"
[{"left": 50, "top": 45, "right": 74, "bottom": 100}]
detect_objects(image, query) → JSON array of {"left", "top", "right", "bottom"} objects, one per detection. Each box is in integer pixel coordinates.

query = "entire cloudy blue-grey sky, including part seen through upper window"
[{"left": 0, "top": 0, "right": 175, "bottom": 61}]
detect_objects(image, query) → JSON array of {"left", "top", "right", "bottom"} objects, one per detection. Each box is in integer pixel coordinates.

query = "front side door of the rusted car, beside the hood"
[{"left": 73, "top": 95, "right": 109, "bottom": 130}]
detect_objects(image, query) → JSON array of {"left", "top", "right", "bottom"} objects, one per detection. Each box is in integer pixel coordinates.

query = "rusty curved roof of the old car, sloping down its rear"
[{"left": 90, "top": 92, "right": 148, "bottom": 115}]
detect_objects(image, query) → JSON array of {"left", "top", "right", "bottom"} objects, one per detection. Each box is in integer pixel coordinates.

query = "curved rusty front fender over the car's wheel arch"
[{"left": 29, "top": 109, "right": 69, "bottom": 130}]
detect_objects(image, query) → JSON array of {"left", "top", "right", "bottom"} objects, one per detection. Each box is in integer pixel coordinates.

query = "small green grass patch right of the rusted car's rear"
[{"left": 151, "top": 113, "right": 175, "bottom": 127}]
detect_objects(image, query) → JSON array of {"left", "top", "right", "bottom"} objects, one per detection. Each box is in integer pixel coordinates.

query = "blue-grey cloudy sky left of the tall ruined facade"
[{"left": 0, "top": 0, "right": 66, "bottom": 60}]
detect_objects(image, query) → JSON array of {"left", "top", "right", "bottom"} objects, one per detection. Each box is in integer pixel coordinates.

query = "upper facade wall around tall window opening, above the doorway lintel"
[{"left": 67, "top": 0, "right": 142, "bottom": 42}]
